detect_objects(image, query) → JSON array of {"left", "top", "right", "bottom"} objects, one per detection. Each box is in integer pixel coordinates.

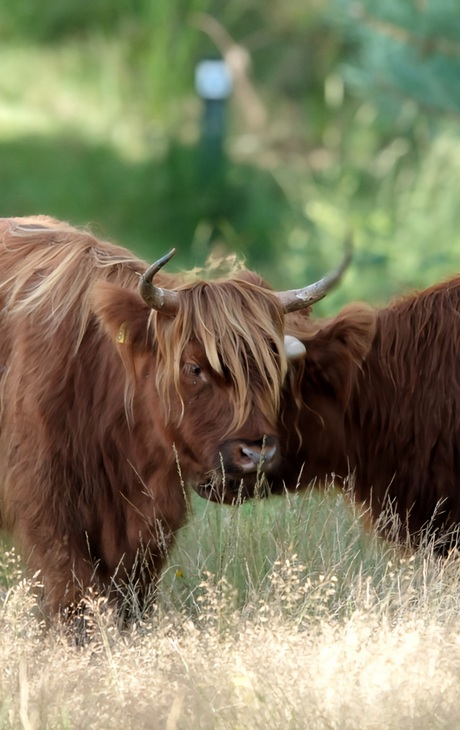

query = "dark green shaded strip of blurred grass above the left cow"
[{"left": 0, "top": 132, "right": 298, "bottom": 283}]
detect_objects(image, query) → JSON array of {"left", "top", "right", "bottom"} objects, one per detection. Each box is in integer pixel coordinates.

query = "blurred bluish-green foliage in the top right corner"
[{"left": 339, "top": 0, "right": 460, "bottom": 115}]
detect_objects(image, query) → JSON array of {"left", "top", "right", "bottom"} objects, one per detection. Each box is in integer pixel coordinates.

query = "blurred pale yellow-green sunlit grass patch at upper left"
[{"left": 0, "top": 37, "right": 176, "bottom": 160}]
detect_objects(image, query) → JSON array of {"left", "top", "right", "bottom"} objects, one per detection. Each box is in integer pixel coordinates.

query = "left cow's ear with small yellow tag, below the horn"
[{"left": 91, "top": 282, "right": 152, "bottom": 350}]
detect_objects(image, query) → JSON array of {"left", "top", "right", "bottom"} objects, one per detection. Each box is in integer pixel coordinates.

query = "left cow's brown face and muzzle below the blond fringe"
[{"left": 164, "top": 340, "right": 282, "bottom": 491}]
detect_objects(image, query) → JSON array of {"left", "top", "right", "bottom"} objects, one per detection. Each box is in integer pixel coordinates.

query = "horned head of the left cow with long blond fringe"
[{"left": 93, "top": 254, "right": 342, "bottom": 494}]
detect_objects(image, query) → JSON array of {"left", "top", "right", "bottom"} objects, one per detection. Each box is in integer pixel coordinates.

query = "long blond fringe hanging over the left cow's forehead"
[{"left": 153, "top": 278, "right": 287, "bottom": 430}]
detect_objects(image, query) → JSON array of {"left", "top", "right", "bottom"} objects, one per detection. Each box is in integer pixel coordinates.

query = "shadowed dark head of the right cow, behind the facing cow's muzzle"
[{"left": 202, "top": 305, "right": 375, "bottom": 502}]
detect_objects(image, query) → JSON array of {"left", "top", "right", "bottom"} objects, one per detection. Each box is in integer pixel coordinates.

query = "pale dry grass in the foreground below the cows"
[{"left": 0, "top": 494, "right": 460, "bottom": 730}]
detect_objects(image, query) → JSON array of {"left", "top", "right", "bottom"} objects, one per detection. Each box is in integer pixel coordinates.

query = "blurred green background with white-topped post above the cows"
[{"left": 0, "top": 0, "right": 460, "bottom": 313}]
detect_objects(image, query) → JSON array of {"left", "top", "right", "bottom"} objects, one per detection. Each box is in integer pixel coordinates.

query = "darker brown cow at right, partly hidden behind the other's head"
[{"left": 273, "top": 279, "right": 460, "bottom": 539}]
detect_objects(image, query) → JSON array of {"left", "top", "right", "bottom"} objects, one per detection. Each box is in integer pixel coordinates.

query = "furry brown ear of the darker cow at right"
[{"left": 305, "top": 304, "right": 376, "bottom": 407}]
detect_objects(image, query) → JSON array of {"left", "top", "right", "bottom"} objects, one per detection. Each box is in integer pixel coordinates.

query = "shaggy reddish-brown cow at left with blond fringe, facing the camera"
[{"left": 0, "top": 216, "right": 324, "bottom": 611}]
